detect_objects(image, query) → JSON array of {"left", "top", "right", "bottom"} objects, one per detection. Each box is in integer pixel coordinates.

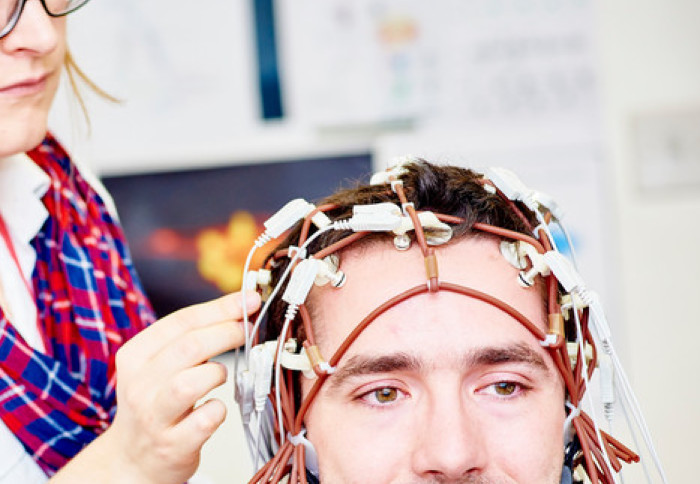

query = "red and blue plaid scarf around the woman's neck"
[{"left": 0, "top": 135, "right": 154, "bottom": 475}]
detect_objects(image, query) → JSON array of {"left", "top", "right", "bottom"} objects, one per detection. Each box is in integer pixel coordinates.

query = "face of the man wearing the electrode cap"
[{"left": 303, "top": 239, "right": 565, "bottom": 484}]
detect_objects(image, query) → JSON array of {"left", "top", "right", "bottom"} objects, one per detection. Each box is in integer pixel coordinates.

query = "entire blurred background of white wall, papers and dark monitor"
[{"left": 51, "top": 0, "right": 700, "bottom": 484}]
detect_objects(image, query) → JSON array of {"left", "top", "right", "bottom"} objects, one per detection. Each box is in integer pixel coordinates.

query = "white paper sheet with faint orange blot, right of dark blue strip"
[{"left": 276, "top": 0, "right": 596, "bottom": 131}]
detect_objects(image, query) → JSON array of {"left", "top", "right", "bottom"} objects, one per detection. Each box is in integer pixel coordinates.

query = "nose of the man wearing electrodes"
[{"left": 412, "top": 389, "right": 488, "bottom": 482}]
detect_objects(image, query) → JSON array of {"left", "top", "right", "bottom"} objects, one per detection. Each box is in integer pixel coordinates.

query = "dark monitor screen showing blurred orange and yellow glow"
[{"left": 102, "top": 153, "right": 372, "bottom": 317}]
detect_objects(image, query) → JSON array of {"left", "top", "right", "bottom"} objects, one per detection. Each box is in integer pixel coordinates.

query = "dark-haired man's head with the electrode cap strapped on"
[{"left": 239, "top": 162, "right": 640, "bottom": 484}]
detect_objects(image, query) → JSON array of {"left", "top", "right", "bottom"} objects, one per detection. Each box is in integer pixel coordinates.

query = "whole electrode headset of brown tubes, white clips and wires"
[{"left": 236, "top": 160, "right": 666, "bottom": 484}]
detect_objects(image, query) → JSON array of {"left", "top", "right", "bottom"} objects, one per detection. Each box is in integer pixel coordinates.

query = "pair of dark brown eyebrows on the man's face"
[{"left": 328, "top": 343, "right": 550, "bottom": 388}]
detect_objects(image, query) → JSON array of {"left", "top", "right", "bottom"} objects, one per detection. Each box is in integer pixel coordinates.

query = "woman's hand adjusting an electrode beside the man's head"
[{"left": 51, "top": 292, "right": 260, "bottom": 484}]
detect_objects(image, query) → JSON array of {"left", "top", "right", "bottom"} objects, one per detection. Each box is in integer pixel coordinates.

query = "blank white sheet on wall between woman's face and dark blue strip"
[{"left": 51, "top": 0, "right": 259, "bottom": 170}]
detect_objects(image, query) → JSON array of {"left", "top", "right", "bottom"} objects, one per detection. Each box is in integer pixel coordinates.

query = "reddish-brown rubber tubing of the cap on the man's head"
[{"left": 250, "top": 179, "right": 639, "bottom": 484}]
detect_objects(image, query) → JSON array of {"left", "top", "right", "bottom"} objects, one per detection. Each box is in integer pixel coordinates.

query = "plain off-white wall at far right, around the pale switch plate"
[{"left": 598, "top": 0, "right": 700, "bottom": 483}]
